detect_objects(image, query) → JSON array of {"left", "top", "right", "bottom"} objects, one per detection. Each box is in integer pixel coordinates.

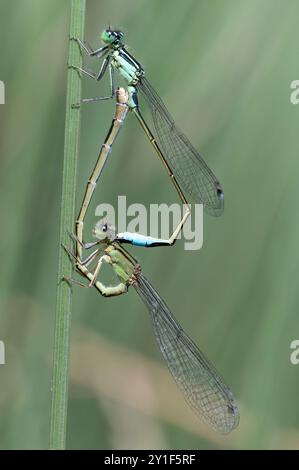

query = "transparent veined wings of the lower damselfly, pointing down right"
[{"left": 134, "top": 274, "right": 239, "bottom": 434}]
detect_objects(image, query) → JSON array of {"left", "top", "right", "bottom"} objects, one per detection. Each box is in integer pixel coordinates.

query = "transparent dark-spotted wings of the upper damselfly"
[{"left": 137, "top": 77, "right": 223, "bottom": 216}]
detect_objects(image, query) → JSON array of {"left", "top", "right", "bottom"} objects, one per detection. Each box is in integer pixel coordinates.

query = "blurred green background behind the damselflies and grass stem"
[{"left": 0, "top": 0, "right": 299, "bottom": 449}]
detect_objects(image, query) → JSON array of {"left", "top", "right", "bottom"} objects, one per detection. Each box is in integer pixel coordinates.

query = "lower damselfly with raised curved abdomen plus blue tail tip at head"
[{"left": 66, "top": 89, "right": 239, "bottom": 434}]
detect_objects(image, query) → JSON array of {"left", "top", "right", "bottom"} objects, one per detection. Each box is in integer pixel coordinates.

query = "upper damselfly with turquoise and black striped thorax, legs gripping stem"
[{"left": 71, "top": 28, "right": 223, "bottom": 216}]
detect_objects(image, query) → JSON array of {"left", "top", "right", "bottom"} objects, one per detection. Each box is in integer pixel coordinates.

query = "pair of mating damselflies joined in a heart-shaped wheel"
[{"left": 67, "top": 28, "right": 239, "bottom": 433}]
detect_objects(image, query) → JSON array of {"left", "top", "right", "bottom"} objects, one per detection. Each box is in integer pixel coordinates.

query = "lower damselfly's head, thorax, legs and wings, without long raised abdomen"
[{"left": 66, "top": 222, "right": 239, "bottom": 434}]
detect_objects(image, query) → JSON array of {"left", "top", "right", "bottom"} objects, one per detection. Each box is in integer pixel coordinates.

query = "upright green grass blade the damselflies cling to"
[{"left": 50, "top": 0, "right": 85, "bottom": 449}]
